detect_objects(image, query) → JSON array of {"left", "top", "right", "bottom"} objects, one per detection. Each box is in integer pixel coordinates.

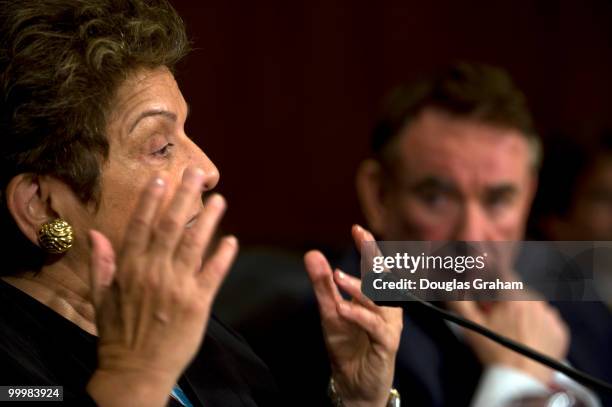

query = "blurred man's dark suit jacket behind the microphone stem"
[{"left": 340, "top": 251, "right": 612, "bottom": 407}]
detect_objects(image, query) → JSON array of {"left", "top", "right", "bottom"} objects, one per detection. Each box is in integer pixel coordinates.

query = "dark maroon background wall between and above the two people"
[{"left": 173, "top": 0, "right": 612, "bottom": 248}]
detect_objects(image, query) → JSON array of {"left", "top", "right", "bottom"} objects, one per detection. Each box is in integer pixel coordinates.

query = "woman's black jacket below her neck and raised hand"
[{"left": 0, "top": 280, "right": 279, "bottom": 407}]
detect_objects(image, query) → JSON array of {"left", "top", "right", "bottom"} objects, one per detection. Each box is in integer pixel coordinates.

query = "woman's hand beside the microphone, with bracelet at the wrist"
[{"left": 304, "top": 226, "right": 403, "bottom": 407}]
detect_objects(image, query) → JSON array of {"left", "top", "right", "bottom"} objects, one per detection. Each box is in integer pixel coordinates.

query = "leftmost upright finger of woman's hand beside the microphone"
[{"left": 304, "top": 250, "right": 342, "bottom": 319}]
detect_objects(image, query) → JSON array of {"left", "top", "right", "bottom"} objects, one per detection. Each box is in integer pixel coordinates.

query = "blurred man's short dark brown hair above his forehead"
[{"left": 371, "top": 62, "right": 541, "bottom": 171}]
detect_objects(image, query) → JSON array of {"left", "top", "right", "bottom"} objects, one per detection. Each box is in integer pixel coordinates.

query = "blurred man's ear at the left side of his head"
[{"left": 356, "top": 159, "right": 386, "bottom": 236}]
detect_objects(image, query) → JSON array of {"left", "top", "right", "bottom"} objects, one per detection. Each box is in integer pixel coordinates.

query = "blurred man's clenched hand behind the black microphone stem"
[{"left": 448, "top": 301, "right": 569, "bottom": 384}]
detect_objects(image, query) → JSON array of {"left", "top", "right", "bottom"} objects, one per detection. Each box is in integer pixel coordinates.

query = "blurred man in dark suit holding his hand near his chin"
[{"left": 357, "top": 64, "right": 600, "bottom": 406}]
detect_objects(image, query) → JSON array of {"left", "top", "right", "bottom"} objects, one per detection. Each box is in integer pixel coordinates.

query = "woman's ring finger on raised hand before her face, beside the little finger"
[{"left": 175, "top": 194, "right": 226, "bottom": 272}]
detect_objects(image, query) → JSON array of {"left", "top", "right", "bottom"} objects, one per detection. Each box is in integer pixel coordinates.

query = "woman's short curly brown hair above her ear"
[{"left": 0, "top": 0, "right": 189, "bottom": 273}]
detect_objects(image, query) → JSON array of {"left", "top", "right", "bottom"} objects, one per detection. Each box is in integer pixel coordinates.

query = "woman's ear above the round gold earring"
[{"left": 6, "top": 174, "right": 58, "bottom": 245}]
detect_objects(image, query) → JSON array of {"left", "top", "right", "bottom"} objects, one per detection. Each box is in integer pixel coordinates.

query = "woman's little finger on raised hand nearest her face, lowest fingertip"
[{"left": 197, "top": 236, "right": 238, "bottom": 305}]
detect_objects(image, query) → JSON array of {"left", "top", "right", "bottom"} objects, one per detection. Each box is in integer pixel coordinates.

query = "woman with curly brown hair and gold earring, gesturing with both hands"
[{"left": 0, "top": 0, "right": 402, "bottom": 407}]
